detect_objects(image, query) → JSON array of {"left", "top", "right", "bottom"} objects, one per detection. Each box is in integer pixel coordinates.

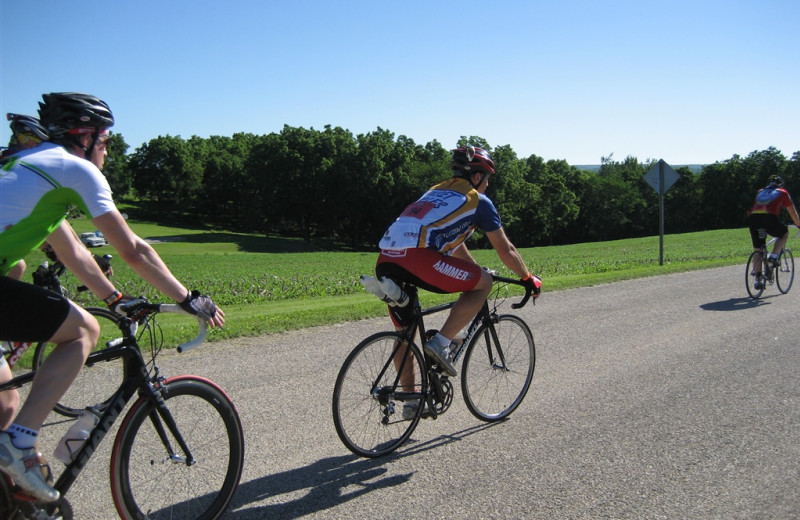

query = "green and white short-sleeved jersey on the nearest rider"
[{"left": 0, "top": 143, "right": 115, "bottom": 275}]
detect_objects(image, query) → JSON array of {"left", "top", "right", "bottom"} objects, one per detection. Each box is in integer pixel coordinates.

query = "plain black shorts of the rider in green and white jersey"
[{"left": 0, "top": 276, "right": 71, "bottom": 342}]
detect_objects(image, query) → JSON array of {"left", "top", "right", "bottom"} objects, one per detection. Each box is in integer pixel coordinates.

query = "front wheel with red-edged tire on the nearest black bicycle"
[{"left": 110, "top": 376, "right": 244, "bottom": 520}]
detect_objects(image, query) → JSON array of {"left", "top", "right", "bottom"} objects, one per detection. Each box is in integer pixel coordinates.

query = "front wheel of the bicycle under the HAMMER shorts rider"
[{"left": 461, "top": 314, "right": 536, "bottom": 422}]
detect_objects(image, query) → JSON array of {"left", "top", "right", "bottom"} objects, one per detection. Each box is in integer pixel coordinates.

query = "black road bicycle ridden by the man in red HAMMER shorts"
[{"left": 332, "top": 274, "right": 536, "bottom": 458}]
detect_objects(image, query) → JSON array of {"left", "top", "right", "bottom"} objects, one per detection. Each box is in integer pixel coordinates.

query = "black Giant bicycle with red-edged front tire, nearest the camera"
[{"left": 0, "top": 299, "right": 244, "bottom": 520}]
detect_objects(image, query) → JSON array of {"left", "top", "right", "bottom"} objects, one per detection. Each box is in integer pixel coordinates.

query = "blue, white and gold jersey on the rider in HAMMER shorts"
[{"left": 378, "top": 177, "right": 502, "bottom": 254}]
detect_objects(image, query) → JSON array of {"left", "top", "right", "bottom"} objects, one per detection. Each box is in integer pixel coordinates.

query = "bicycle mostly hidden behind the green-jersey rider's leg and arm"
[{"left": 1, "top": 255, "right": 125, "bottom": 418}]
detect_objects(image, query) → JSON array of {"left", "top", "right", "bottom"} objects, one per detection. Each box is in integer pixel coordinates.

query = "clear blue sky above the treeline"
[{"left": 0, "top": 0, "right": 800, "bottom": 165}]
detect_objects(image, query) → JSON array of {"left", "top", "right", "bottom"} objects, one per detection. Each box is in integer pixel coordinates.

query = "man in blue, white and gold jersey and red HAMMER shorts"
[{"left": 375, "top": 146, "right": 541, "bottom": 382}]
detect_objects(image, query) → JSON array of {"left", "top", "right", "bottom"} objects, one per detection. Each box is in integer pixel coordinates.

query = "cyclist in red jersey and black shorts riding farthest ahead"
[{"left": 748, "top": 175, "right": 800, "bottom": 290}]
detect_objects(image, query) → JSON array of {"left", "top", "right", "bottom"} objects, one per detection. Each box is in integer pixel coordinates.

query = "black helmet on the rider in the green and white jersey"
[{"left": 39, "top": 92, "right": 114, "bottom": 140}]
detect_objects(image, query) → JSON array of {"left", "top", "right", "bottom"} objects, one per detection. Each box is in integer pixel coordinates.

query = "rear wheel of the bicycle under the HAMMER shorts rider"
[{"left": 332, "top": 332, "right": 428, "bottom": 458}]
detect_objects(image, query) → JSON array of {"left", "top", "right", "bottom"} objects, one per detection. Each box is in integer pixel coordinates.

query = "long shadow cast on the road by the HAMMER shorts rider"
[{"left": 225, "top": 423, "right": 498, "bottom": 520}]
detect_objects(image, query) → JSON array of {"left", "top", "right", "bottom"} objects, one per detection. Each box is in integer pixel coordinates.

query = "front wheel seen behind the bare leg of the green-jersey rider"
[{"left": 32, "top": 307, "right": 125, "bottom": 417}]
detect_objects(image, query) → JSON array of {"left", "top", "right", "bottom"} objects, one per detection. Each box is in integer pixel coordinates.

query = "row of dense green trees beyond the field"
[{"left": 105, "top": 126, "right": 800, "bottom": 249}]
